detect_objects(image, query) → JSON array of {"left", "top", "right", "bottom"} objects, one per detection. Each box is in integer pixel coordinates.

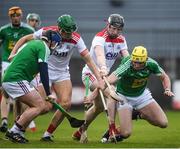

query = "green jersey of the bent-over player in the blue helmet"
[{"left": 2, "top": 40, "right": 50, "bottom": 82}]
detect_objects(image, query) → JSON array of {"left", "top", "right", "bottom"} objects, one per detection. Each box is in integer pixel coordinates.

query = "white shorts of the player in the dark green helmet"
[{"left": 48, "top": 69, "right": 70, "bottom": 85}]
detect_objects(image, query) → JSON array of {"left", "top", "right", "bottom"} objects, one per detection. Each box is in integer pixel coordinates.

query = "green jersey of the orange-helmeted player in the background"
[{"left": 0, "top": 23, "right": 34, "bottom": 62}]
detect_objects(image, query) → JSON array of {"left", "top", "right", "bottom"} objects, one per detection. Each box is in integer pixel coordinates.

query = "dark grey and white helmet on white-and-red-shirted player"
[{"left": 108, "top": 14, "right": 124, "bottom": 28}]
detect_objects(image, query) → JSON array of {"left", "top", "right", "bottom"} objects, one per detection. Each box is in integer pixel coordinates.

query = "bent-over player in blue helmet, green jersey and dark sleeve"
[{"left": 2, "top": 31, "right": 61, "bottom": 143}]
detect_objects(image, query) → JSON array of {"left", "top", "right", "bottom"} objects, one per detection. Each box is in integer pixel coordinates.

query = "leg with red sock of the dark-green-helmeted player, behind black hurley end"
[{"left": 42, "top": 80, "right": 72, "bottom": 141}]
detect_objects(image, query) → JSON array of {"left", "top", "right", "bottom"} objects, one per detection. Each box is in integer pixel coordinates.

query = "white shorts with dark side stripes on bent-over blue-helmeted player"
[{"left": 2, "top": 80, "right": 34, "bottom": 99}]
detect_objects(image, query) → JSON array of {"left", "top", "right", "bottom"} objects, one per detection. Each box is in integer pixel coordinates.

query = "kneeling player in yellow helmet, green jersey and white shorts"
[{"left": 101, "top": 46, "right": 174, "bottom": 143}]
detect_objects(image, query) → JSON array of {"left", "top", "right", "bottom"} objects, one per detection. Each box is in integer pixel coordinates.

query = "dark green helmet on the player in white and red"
[{"left": 57, "top": 14, "right": 77, "bottom": 33}]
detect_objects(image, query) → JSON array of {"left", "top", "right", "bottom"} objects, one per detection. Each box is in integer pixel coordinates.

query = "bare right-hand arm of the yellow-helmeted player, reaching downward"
[{"left": 159, "top": 72, "right": 174, "bottom": 97}]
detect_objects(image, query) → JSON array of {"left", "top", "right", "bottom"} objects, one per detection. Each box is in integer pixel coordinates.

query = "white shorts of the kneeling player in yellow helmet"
[{"left": 117, "top": 88, "right": 155, "bottom": 110}]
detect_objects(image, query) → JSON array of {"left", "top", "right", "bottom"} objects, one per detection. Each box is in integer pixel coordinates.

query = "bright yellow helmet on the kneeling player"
[{"left": 131, "top": 46, "right": 148, "bottom": 63}]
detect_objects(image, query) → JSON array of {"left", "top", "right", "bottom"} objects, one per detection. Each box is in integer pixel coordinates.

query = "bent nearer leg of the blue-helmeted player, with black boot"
[{"left": 6, "top": 90, "right": 48, "bottom": 143}]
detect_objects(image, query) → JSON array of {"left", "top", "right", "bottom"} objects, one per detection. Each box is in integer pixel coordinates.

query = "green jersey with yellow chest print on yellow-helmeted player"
[{"left": 113, "top": 56, "right": 164, "bottom": 97}]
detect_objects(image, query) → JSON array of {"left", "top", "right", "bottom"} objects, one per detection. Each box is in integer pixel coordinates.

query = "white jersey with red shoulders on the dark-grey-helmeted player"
[{"left": 83, "top": 29, "right": 128, "bottom": 73}]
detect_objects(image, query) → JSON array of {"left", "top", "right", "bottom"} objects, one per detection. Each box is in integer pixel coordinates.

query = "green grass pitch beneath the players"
[{"left": 0, "top": 111, "right": 180, "bottom": 148}]
